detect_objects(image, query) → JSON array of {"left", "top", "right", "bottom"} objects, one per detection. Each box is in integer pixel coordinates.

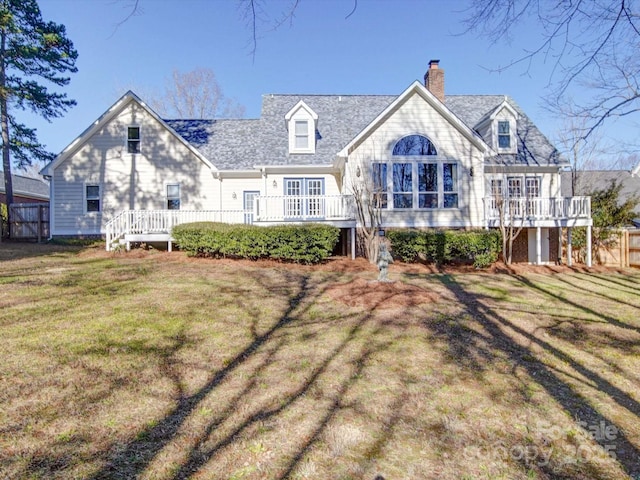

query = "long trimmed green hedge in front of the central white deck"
[{"left": 172, "top": 222, "right": 340, "bottom": 263}]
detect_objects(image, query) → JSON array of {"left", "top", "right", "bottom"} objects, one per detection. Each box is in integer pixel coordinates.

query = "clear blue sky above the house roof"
[{"left": 16, "top": 0, "right": 636, "bottom": 165}]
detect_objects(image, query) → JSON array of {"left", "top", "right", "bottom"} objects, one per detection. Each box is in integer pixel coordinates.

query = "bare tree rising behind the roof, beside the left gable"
[{"left": 149, "top": 68, "right": 245, "bottom": 119}]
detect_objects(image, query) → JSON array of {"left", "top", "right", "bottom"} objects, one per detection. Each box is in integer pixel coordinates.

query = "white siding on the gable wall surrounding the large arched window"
[{"left": 345, "top": 94, "right": 484, "bottom": 231}]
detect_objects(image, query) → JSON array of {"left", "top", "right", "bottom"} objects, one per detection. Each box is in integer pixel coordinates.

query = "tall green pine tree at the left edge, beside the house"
[{"left": 0, "top": 0, "right": 78, "bottom": 210}]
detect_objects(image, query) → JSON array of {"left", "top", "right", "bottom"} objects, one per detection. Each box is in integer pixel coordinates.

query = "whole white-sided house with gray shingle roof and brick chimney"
[{"left": 42, "top": 60, "right": 591, "bottom": 263}]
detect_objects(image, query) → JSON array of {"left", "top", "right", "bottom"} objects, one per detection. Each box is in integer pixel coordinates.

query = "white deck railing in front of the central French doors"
[{"left": 255, "top": 195, "right": 355, "bottom": 222}]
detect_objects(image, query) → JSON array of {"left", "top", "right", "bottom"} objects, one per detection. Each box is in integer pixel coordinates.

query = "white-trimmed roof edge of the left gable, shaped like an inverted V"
[{"left": 40, "top": 90, "right": 215, "bottom": 176}]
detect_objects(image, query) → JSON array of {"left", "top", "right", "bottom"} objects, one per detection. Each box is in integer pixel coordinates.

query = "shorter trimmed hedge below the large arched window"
[{"left": 386, "top": 230, "right": 502, "bottom": 268}]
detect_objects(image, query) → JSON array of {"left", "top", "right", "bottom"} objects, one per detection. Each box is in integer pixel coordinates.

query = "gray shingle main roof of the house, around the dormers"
[{"left": 165, "top": 91, "right": 560, "bottom": 170}]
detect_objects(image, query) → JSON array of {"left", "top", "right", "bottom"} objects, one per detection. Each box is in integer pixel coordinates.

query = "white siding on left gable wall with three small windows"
[{"left": 52, "top": 102, "right": 218, "bottom": 235}]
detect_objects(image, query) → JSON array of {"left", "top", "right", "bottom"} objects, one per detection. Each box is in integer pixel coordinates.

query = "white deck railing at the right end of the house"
[{"left": 484, "top": 197, "right": 591, "bottom": 221}]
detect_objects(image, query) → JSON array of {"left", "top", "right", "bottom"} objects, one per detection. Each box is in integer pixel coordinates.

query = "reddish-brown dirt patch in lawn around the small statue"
[{"left": 327, "top": 278, "right": 438, "bottom": 309}]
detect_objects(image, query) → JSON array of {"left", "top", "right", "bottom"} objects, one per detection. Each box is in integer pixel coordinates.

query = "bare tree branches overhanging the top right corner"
[{"left": 466, "top": 0, "right": 640, "bottom": 145}]
